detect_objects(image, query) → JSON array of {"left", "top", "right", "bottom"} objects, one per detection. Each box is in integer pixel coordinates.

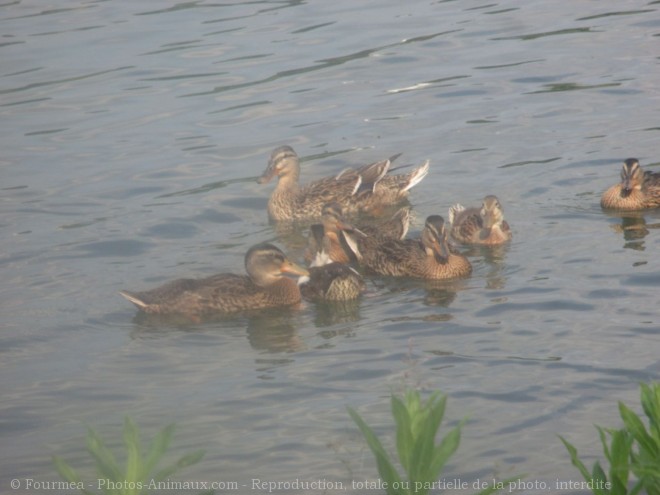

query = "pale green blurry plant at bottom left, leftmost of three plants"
[{"left": 53, "top": 417, "right": 213, "bottom": 495}]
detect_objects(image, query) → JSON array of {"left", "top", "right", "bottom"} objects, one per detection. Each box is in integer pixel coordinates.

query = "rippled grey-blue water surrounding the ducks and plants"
[{"left": 0, "top": 0, "right": 660, "bottom": 493}]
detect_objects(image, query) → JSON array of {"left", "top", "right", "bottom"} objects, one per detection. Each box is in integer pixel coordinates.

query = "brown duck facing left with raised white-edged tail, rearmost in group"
[{"left": 258, "top": 146, "right": 429, "bottom": 221}]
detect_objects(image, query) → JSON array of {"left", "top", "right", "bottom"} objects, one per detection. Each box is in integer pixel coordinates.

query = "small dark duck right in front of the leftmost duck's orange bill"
[{"left": 298, "top": 224, "right": 365, "bottom": 301}]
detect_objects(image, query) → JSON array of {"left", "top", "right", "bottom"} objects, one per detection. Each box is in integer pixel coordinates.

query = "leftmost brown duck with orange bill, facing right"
[{"left": 120, "top": 243, "right": 309, "bottom": 318}]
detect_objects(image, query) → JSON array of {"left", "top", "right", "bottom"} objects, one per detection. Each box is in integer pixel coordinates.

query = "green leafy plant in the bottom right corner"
[{"left": 559, "top": 383, "right": 660, "bottom": 495}]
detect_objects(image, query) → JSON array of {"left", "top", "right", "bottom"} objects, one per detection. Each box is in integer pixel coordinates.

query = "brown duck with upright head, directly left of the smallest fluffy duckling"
[{"left": 359, "top": 215, "right": 472, "bottom": 280}]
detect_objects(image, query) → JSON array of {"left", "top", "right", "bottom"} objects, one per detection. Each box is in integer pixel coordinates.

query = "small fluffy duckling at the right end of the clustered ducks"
[{"left": 449, "top": 195, "right": 512, "bottom": 245}]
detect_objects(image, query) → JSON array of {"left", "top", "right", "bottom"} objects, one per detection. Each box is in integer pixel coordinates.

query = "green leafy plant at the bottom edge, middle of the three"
[{"left": 348, "top": 390, "right": 513, "bottom": 495}]
